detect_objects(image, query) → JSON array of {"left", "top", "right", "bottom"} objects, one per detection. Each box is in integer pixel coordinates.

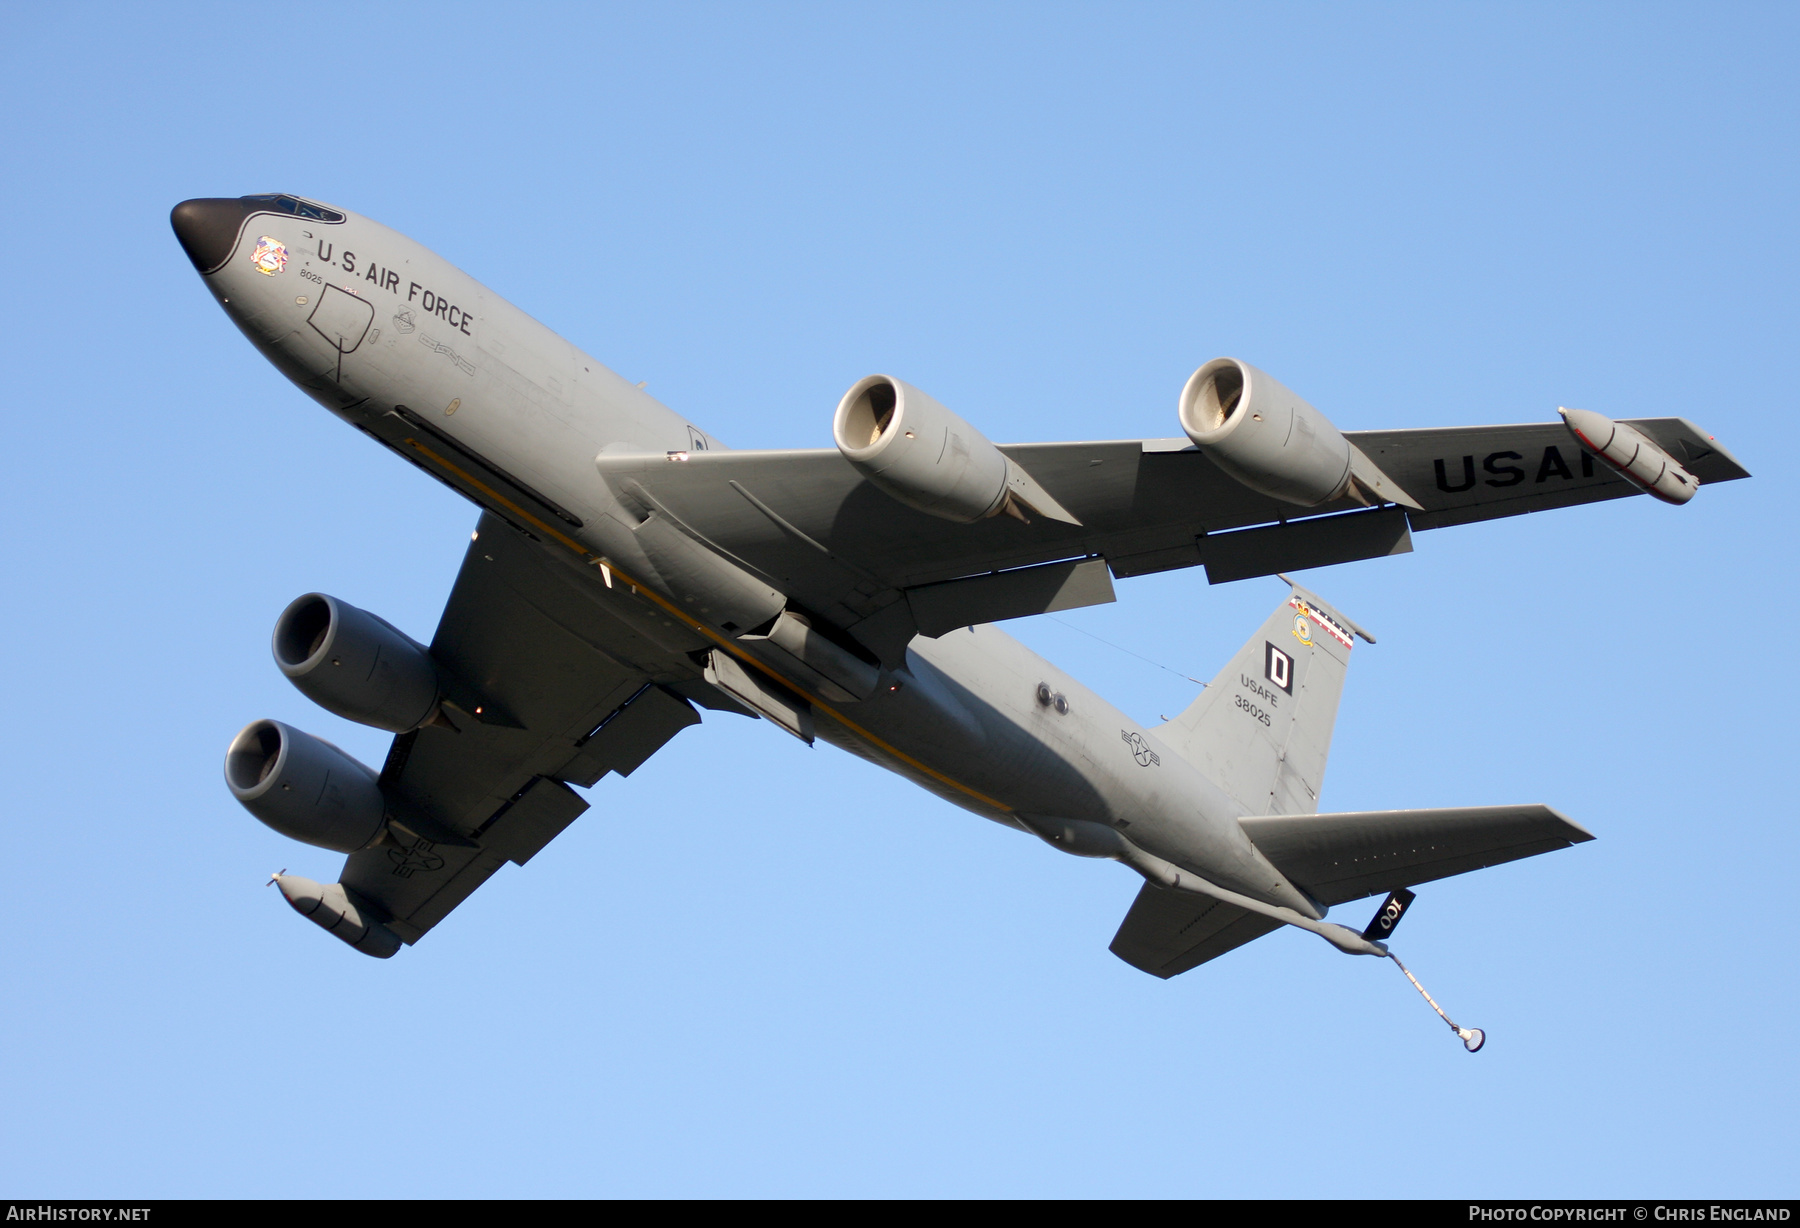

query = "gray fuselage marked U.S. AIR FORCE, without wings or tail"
[{"left": 178, "top": 202, "right": 1318, "bottom": 916}]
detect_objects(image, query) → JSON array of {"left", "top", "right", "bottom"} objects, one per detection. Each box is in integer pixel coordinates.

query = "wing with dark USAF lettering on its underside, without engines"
[{"left": 598, "top": 418, "right": 1746, "bottom": 661}]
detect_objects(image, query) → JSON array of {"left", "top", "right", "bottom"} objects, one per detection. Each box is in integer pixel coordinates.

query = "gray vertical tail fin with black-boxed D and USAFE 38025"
[{"left": 1157, "top": 576, "right": 1373, "bottom": 814}]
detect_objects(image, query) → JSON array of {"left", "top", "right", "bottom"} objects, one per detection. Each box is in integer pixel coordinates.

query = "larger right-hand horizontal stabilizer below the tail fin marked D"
[{"left": 1240, "top": 807, "right": 1593, "bottom": 904}]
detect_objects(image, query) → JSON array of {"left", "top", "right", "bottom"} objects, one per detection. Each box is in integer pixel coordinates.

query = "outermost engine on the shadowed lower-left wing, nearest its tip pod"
[{"left": 225, "top": 720, "right": 387, "bottom": 853}]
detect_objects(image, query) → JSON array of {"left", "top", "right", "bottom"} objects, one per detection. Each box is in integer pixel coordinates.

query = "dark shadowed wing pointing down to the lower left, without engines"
[{"left": 342, "top": 515, "right": 700, "bottom": 944}]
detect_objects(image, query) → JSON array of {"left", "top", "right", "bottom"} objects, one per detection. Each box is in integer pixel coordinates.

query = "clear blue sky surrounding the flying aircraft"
[{"left": 0, "top": 4, "right": 1800, "bottom": 1197}]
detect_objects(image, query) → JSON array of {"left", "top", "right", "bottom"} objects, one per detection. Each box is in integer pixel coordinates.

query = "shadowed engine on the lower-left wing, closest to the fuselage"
[{"left": 270, "top": 592, "right": 439, "bottom": 733}]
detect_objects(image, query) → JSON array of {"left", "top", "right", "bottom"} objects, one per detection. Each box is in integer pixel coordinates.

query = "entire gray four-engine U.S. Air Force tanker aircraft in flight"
[{"left": 171, "top": 193, "right": 1748, "bottom": 1048}]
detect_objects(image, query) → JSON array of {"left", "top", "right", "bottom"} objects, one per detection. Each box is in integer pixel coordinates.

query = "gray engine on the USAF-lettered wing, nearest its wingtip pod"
[{"left": 1181, "top": 358, "right": 1354, "bottom": 508}]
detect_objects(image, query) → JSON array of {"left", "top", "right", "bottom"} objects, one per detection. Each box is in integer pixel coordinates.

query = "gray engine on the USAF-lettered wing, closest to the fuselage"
[{"left": 832, "top": 375, "right": 1080, "bottom": 524}]
